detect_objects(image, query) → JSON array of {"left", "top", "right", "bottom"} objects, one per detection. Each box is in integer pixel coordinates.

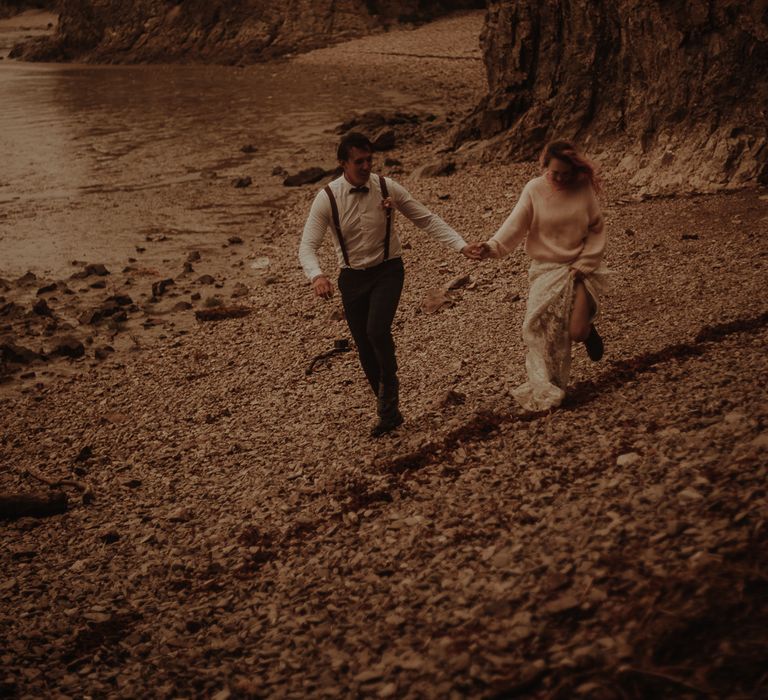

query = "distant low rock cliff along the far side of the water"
[{"left": 12, "top": 0, "right": 485, "bottom": 63}]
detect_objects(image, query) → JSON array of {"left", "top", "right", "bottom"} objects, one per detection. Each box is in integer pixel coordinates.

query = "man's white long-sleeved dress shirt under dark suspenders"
[{"left": 299, "top": 175, "right": 467, "bottom": 280}]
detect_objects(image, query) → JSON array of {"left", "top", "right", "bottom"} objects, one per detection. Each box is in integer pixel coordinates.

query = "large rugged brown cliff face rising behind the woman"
[{"left": 456, "top": 0, "right": 768, "bottom": 193}]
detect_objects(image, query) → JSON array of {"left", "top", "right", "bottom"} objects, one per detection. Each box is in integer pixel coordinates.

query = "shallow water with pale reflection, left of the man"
[{"left": 0, "top": 15, "right": 432, "bottom": 277}]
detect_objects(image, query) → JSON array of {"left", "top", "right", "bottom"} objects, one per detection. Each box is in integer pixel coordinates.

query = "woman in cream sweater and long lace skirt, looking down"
[{"left": 475, "top": 141, "right": 606, "bottom": 411}]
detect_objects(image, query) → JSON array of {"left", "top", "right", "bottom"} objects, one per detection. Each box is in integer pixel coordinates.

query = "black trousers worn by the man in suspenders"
[{"left": 339, "top": 258, "right": 405, "bottom": 394}]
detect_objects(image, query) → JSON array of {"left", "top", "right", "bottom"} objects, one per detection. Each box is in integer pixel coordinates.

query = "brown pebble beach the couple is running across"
[{"left": 0, "top": 15, "right": 768, "bottom": 700}]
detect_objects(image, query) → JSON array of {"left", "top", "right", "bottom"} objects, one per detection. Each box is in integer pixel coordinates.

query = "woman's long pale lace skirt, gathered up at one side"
[{"left": 512, "top": 260, "right": 608, "bottom": 411}]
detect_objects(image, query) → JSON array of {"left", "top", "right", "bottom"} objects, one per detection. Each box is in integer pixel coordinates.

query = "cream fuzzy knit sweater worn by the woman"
[{"left": 488, "top": 175, "right": 605, "bottom": 274}]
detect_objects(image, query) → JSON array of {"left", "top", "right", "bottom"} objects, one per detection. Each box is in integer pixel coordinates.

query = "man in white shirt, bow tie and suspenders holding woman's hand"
[{"left": 299, "top": 132, "right": 479, "bottom": 437}]
